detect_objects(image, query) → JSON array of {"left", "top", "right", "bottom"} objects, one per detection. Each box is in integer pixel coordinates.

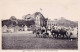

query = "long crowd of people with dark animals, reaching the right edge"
[{"left": 33, "top": 26, "right": 78, "bottom": 37}]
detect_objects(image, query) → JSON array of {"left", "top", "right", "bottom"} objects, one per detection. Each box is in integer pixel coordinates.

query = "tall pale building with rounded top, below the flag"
[{"left": 32, "top": 12, "right": 45, "bottom": 27}]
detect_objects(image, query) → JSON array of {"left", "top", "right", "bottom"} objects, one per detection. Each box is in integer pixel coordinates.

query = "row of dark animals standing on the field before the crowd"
[{"left": 34, "top": 26, "right": 72, "bottom": 38}]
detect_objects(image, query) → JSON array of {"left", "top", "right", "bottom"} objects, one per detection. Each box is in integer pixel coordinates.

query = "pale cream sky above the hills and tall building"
[{"left": 0, "top": 0, "right": 80, "bottom": 21}]
